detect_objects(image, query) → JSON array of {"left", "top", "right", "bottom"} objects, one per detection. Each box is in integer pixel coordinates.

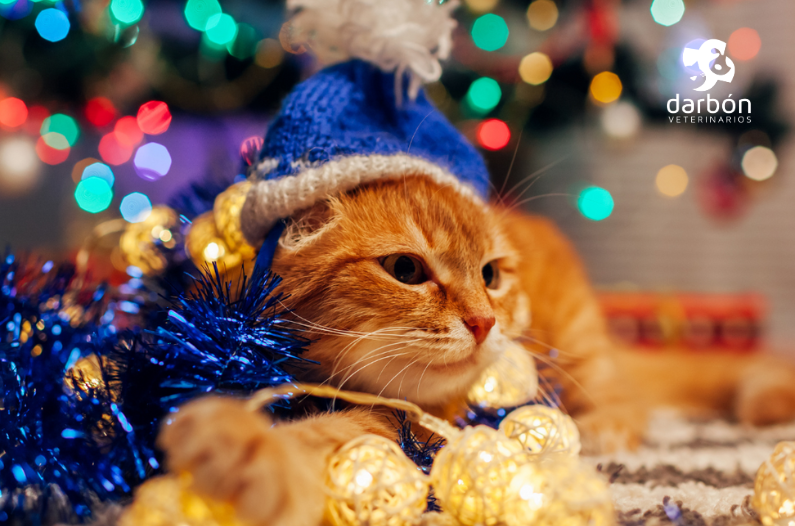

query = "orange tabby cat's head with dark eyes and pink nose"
[{"left": 273, "top": 176, "right": 528, "bottom": 405}]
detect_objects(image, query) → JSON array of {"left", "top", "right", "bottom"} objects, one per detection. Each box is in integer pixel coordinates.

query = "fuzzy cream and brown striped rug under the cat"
[{"left": 585, "top": 411, "right": 795, "bottom": 526}]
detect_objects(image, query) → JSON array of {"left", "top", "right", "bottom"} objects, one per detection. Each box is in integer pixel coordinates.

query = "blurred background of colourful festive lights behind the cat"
[{"left": 0, "top": 0, "right": 795, "bottom": 352}]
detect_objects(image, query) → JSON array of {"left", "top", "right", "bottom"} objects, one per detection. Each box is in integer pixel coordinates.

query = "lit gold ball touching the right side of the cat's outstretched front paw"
[{"left": 326, "top": 435, "right": 430, "bottom": 526}]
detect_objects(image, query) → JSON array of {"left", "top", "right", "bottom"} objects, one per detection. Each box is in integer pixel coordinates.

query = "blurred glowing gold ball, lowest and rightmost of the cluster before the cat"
[{"left": 504, "top": 457, "right": 615, "bottom": 526}]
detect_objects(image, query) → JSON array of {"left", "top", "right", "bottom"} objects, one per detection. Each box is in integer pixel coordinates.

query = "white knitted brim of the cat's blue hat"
[{"left": 240, "top": 153, "right": 484, "bottom": 247}]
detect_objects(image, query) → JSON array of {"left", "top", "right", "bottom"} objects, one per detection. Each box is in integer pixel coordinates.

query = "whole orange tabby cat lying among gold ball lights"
[{"left": 160, "top": 176, "right": 795, "bottom": 526}]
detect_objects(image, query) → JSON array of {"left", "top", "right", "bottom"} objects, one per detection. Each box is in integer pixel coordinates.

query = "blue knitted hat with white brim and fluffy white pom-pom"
[{"left": 241, "top": 0, "right": 489, "bottom": 251}]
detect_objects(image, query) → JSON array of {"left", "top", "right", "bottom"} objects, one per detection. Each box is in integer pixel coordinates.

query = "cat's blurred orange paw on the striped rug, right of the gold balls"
[{"left": 575, "top": 404, "right": 647, "bottom": 455}]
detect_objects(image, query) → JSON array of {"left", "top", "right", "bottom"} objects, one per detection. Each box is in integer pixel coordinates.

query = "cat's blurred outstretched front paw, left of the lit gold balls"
[{"left": 158, "top": 397, "right": 325, "bottom": 526}]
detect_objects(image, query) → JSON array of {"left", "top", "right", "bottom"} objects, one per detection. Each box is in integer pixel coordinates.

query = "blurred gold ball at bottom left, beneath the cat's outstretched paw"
[{"left": 119, "top": 474, "right": 244, "bottom": 526}]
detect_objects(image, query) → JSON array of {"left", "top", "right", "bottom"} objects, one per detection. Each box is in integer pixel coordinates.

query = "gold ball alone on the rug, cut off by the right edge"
[{"left": 752, "top": 442, "right": 795, "bottom": 526}]
